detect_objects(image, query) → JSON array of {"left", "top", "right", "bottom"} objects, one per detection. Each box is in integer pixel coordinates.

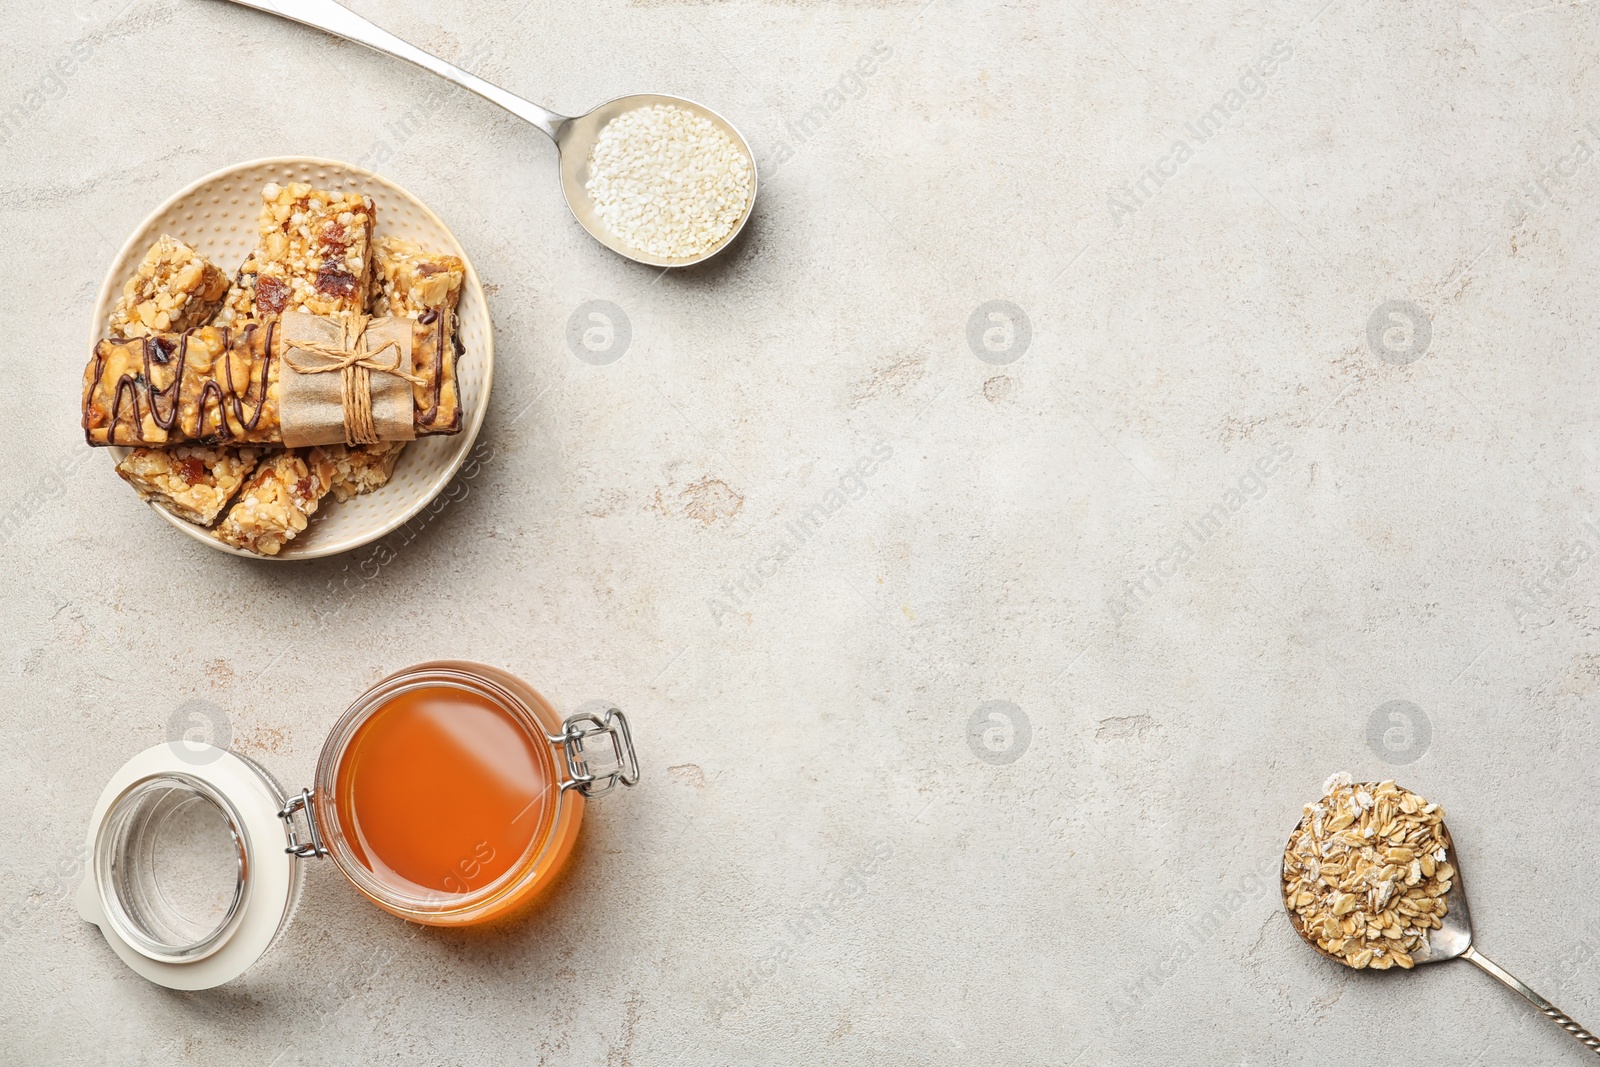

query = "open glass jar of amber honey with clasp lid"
[{"left": 77, "top": 661, "right": 638, "bottom": 989}]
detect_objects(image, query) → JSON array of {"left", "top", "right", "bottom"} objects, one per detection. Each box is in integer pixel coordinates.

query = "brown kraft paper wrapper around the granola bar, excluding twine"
[{"left": 278, "top": 312, "right": 416, "bottom": 448}]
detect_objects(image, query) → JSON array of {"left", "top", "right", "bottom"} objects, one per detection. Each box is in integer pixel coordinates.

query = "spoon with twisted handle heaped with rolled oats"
[{"left": 1282, "top": 774, "right": 1600, "bottom": 1054}]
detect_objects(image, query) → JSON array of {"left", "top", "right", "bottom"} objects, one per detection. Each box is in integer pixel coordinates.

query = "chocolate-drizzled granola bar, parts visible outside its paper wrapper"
[{"left": 83, "top": 320, "right": 461, "bottom": 446}]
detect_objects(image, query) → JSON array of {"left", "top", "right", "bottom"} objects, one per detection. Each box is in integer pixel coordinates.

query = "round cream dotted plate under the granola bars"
[{"left": 85, "top": 157, "right": 494, "bottom": 560}]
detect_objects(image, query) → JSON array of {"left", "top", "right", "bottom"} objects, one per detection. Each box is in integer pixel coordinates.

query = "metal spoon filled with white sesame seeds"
[{"left": 217, "top": 0, "right": 755, "bottom": 267}]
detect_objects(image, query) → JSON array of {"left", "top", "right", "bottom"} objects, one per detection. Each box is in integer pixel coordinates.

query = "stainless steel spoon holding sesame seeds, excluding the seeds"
[{"left": 217, "top": 0, "right": 755, "bottom": 267}]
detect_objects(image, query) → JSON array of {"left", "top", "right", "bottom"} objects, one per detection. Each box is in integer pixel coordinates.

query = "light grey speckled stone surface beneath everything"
[{"left": 0, "top": 0, "right": 1600, "bottom": 1067}]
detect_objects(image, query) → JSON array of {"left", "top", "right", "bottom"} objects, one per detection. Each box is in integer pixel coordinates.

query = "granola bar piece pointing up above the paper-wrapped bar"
[{"left": 254, "top": 182, "right": 374, "bottom": 320}]
